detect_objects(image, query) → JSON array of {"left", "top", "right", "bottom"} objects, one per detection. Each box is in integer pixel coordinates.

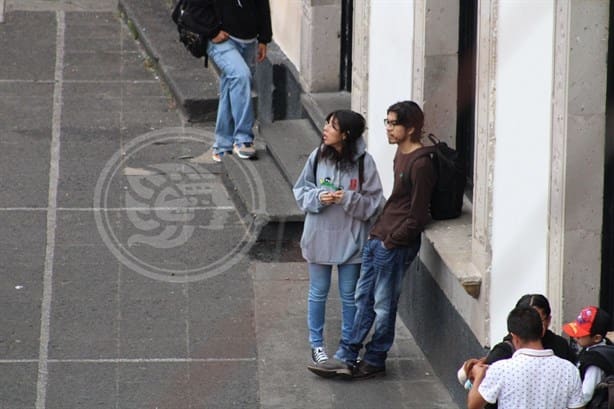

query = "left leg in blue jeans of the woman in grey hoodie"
[{"left": 307, "top": 263, "right": 332, "bottom": 348}]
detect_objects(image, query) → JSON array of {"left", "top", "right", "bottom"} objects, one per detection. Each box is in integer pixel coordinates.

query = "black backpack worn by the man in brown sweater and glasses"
[{"left": 410, "top": 134, "right": 467, "bottom": 220}]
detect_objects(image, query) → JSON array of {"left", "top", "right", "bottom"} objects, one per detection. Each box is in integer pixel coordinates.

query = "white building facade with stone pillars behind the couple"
[{"left": 270, "top": 0, "right": 614, "bottom": 402}]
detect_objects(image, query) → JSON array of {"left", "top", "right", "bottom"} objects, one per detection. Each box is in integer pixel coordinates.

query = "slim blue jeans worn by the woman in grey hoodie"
[{"left": 307, "top": 263, "right": 360, "bottom": 348}]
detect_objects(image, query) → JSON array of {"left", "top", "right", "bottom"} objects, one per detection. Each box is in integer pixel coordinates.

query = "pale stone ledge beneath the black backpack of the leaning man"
[{"left": 424, "top": 206, "right": 482, "bottom": 298}]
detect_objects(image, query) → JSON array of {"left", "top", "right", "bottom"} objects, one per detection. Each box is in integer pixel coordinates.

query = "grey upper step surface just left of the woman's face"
[{"left": 260, "top": 119, "right": 320, "bottom": 186}]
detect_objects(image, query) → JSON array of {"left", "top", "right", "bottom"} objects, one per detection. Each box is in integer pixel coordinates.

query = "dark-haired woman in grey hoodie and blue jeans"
[{"left": 293, "top": 110, "right": 384, "bottom": 363}]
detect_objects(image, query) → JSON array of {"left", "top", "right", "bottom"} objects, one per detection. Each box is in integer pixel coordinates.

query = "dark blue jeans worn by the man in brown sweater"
[{"left": 335, "top": 239, "right": 420, "bottom": 367}]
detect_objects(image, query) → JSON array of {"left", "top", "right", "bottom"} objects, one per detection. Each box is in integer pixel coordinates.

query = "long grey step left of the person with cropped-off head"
[{"left": 118, "top": 0, "right": 219, "bottom": 122}]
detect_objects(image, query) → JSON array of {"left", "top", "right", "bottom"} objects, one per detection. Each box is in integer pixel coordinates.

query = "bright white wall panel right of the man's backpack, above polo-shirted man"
[{"left": 490, "top": 1, "right": 558, "bottom": 339}]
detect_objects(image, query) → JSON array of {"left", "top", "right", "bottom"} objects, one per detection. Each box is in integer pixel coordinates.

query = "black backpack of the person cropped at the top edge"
[{"left": 171, "top": 0, "right": 208, "bottom": 67}]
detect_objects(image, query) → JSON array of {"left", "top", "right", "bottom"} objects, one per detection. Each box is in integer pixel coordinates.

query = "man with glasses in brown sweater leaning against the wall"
[{"left": 308, "top": 101, "right": 436, "bottom": 379}]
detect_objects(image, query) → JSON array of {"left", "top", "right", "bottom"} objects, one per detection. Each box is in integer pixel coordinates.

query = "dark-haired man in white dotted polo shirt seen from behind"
[{"left": 467, "top": 307, "right": 584, "bottom": 409}]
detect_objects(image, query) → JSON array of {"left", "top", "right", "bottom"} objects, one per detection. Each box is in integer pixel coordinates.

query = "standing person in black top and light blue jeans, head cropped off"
[{"left": 189, "top": 0, "right": 273, "bottom": 162}]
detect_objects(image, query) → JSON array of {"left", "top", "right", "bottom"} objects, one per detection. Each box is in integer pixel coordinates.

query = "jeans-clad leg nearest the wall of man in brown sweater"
[{"left": 364, "top": 242, "right": 420, "bottom": 368}]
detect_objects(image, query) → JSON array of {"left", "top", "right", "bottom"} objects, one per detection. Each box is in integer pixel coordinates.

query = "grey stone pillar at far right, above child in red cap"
[{"left": 557, "top": 1, "right": 609, "bottom": 321}]
